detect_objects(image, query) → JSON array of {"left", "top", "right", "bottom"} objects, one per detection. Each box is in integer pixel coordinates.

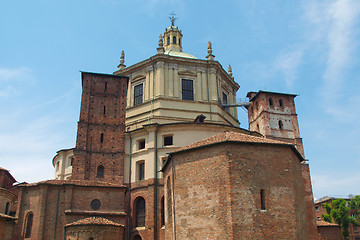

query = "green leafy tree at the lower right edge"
[{"left": 321, "top": 196, "right": 360, "bottom": 240}]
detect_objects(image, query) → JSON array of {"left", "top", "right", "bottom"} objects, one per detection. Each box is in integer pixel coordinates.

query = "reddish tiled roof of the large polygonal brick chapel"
[{"left": 174, "top": 131, "right": 292, "bottom": 153}]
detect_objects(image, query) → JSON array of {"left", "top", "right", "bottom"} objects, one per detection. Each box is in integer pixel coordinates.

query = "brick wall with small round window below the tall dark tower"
[{"left": 14, "top": 180, "right": 126, "bottom": 240}]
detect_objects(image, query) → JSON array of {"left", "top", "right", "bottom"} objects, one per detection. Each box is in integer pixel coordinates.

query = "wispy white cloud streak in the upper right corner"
[{"left": 305, "top": 0, "right": 360, "bottom": 114}]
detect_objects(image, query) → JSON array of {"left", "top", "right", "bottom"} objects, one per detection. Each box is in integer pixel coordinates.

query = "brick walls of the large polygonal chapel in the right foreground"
[{"left": 165, "top": 142, "right": 318, "bottom": 240}]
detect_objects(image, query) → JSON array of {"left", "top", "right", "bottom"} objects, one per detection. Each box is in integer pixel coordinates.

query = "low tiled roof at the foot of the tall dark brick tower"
[{"left": 19, "top": 180, "right": 125, "bottom": 187}]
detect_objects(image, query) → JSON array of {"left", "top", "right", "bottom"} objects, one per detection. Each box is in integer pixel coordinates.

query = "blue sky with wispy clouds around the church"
[{"left": 0, "top": 0, "right": 360, "bottom": 198}]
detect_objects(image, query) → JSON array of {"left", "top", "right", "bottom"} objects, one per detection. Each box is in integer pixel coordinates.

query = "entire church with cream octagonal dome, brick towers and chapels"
[{"left": 2, "top": 18, "right": 320, "bottom": 240}]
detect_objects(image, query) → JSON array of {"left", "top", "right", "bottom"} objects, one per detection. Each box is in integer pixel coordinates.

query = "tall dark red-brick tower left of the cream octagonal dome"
[{"left": 72, "top": 72, "right": 128, "bottom": 184}]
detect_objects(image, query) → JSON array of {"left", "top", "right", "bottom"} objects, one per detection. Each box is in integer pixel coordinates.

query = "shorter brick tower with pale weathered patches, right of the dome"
[{"left": 247, "top": 91, "right": 304, "bottom": 157}]
